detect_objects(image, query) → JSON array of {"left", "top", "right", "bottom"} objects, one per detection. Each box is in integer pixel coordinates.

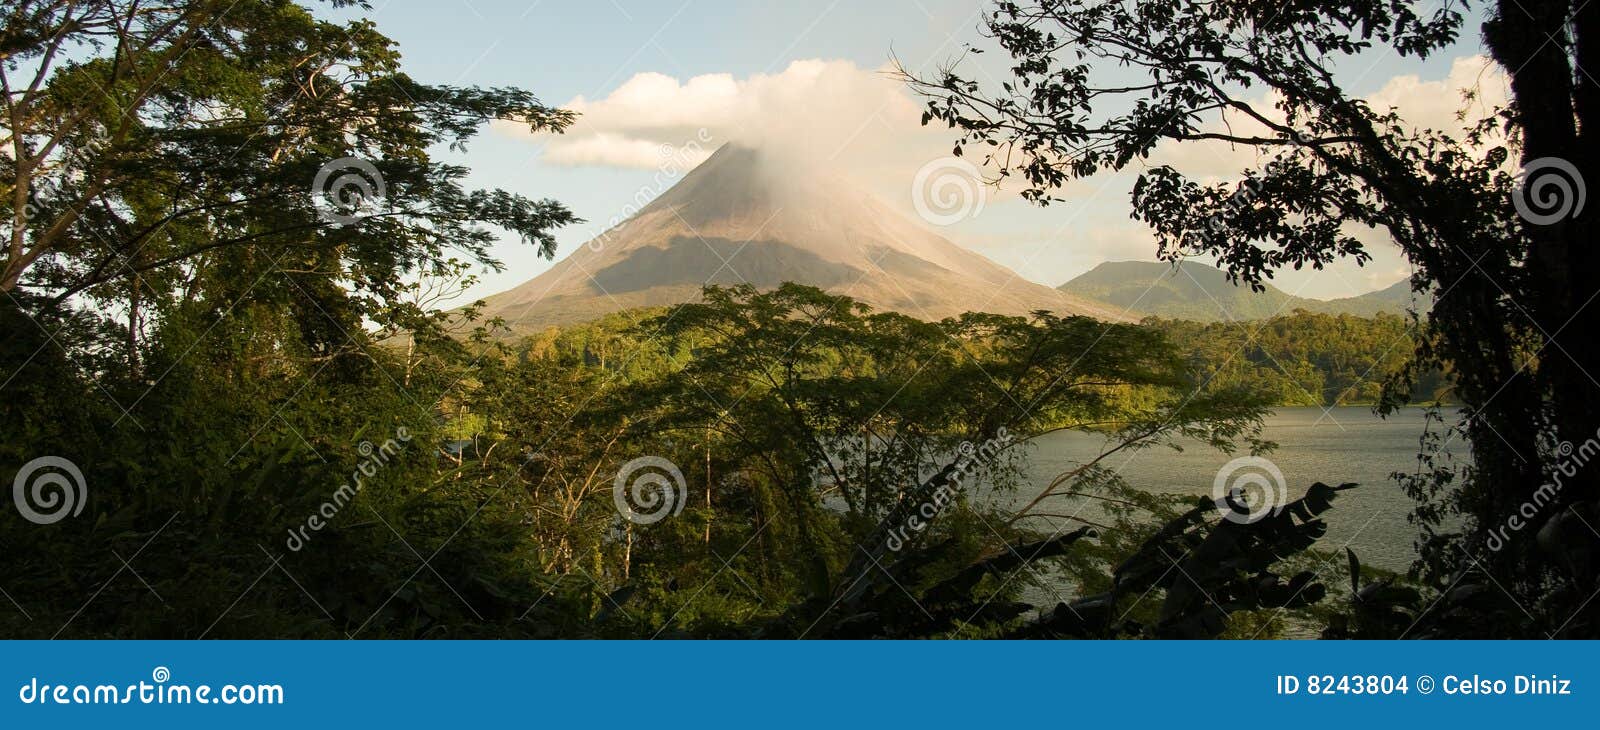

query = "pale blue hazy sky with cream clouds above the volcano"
[{"left": 350, "top": 0, "right": 1504, "bottom": 298}]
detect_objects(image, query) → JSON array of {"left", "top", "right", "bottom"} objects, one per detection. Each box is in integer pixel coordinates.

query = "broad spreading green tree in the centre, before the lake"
[{"left": 621, "top": 283, "right": 1270, "bottom": 636}]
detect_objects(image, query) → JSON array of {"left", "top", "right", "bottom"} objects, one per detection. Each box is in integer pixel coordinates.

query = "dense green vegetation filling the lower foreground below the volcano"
[{"left": 0, "top": 265, "right": 1388, "bottom": 637}]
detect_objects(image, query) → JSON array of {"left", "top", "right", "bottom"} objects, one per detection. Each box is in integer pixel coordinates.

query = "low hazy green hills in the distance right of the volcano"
[{"left": 1058, "top": 261, "right": 1411, "bottom": 322}]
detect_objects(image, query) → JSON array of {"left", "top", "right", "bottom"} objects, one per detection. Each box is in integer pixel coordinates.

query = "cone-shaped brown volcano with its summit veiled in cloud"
[{"left": 485, "top": 144, "right": 1126, "bottom": 331}]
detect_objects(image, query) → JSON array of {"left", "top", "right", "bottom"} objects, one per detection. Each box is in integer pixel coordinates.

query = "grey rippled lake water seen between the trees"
[{"left": 1002, "top": 407, "right": 1466, "bottom": 570}]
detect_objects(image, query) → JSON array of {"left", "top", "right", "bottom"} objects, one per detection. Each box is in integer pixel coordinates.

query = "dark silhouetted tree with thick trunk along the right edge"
[{"left": 906, "top": 0, "right": 1600, "bottom": 634}]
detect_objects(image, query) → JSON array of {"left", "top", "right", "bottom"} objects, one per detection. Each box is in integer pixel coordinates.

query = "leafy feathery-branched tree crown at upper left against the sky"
[{"left": 0, "top": 0, "right": 574, "bottom": 357}]
